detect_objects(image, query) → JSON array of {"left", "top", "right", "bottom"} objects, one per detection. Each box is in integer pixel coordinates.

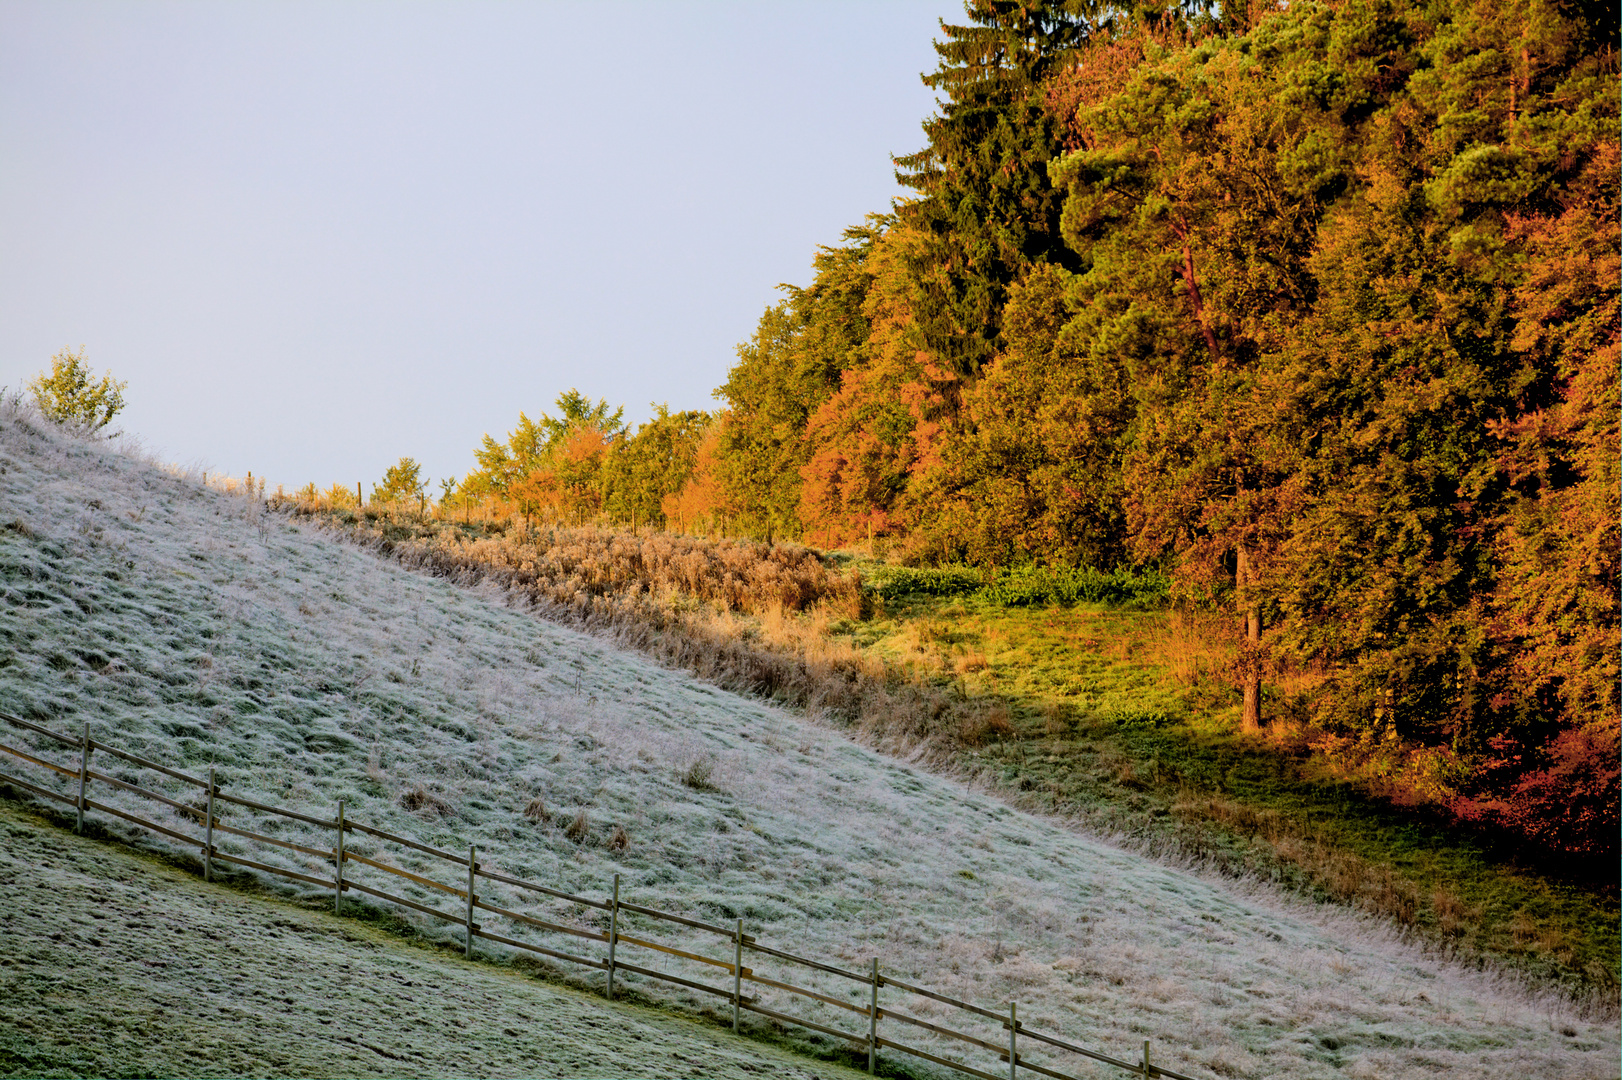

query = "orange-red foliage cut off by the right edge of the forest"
[{"left": 1489, "top": 141, "right": 1622, "bottom": 722}]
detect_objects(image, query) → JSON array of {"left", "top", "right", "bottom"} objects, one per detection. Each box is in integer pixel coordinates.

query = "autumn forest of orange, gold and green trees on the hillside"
[{"left": 332, "top": 0, "right": 1619, "bottom": 861}]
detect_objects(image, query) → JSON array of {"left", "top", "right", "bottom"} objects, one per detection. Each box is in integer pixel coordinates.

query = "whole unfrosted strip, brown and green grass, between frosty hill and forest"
[{"left": 300, "top": 506, "right": 1619, "bottom": 992}]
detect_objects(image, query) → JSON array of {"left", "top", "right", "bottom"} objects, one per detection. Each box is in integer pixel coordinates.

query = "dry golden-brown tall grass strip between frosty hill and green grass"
[{"left": 294, "top": 504, "right": 1011, "bottom": 761}]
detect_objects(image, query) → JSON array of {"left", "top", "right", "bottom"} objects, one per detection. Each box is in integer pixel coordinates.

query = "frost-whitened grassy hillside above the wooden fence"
[{"left": 0, "top": 397, "right": 1617, "bottom": 1077}]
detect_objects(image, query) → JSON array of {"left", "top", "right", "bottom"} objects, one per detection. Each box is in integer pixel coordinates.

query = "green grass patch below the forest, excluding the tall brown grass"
[{"left": 837, "top": 595, "right": 1622, "bottom": 996}]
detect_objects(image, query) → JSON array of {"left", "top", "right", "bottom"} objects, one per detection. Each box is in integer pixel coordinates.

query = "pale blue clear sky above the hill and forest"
[{"left": 0, "top": 0, "right": 962, "bottom": 486}]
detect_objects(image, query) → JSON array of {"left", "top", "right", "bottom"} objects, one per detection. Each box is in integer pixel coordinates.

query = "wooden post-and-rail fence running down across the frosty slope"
[{"left": 0, "top": 714, "right": 1195, "bottom": 1080}]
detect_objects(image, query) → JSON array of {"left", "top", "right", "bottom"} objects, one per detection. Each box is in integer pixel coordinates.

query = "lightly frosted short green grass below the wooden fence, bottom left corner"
[{"left": 0, "top": 803, "right": 866, "bottom": 1080}]
